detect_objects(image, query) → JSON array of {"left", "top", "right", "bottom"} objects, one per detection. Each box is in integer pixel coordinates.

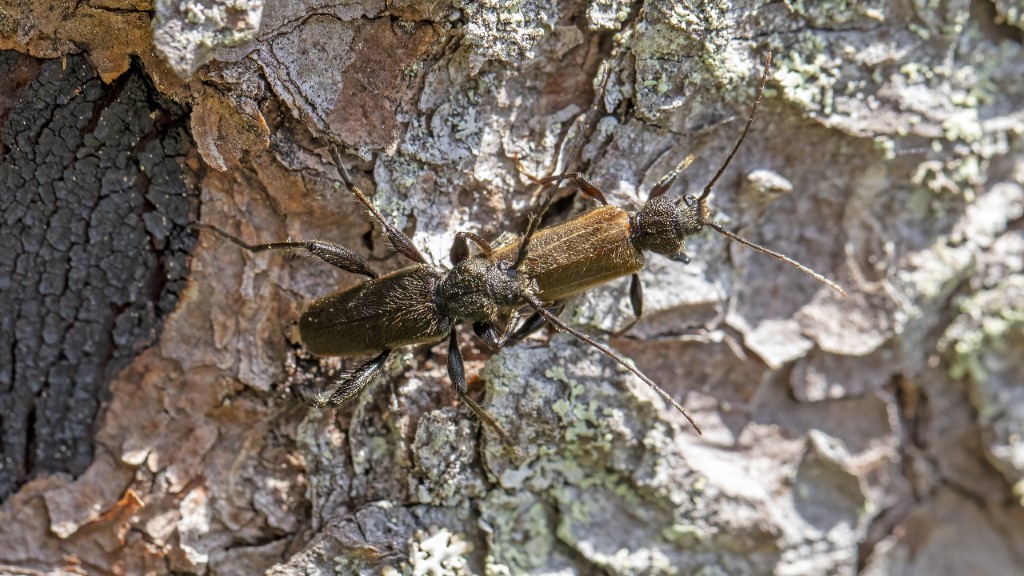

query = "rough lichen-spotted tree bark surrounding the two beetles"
[{"left": 0, "top": 0, "right": 1024, "bottom": 575}]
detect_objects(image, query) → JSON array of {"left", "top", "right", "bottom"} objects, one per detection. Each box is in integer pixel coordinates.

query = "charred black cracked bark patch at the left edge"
[{"left": 0, "top": 52, "right": 196, "bottom": 499}]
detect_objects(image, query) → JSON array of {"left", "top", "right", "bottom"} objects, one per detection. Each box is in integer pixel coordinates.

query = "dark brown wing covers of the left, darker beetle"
[{"left": 299, "top": 264, "right": 452, "bottom": 356}]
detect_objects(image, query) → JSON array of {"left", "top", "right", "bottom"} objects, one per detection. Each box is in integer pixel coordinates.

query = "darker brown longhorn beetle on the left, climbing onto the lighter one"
[{"left": 196, "top": 131, "right": 699, "bottom": 455}]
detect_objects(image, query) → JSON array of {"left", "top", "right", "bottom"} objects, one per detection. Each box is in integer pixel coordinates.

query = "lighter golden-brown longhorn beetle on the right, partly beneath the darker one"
[{"left": 475, "top": 53, "right": 846, "bottom": 403}]
